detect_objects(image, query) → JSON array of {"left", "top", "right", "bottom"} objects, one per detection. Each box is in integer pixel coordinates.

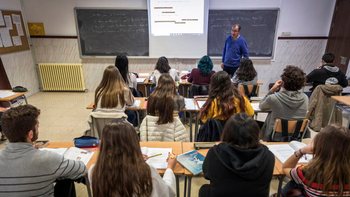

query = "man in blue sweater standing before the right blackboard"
[{"left": 221, "top": 24, "right": 249, "bottom": 77}]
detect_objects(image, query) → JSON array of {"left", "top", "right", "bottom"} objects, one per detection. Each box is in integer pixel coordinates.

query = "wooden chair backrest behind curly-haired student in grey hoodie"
[{"left": 271, "top": 118, "right": 309, "bottom": 141}]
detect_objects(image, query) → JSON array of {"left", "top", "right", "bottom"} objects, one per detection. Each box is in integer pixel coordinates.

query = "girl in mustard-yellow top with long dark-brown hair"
[{"left": 199, "top": 71, "right": 254, "bottom": 123}]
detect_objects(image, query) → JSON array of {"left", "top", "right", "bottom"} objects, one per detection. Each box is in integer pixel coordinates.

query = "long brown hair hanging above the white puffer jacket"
[{"left": 147, "top": 74, "right": 177, "bottom": 125}]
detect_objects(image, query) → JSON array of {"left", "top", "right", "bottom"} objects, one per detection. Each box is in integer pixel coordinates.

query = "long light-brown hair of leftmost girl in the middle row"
[{"left": 94, "top": 66, "right": 130, "bottom": 108}]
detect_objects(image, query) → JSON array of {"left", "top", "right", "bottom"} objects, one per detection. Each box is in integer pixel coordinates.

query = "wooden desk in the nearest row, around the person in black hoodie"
[{"left": 182, "top": 142, "right": 289, "bottom": 197}]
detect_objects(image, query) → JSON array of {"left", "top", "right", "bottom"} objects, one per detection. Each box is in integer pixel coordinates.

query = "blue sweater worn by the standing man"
[{"left": 221, "top": 35, "right": 249, "bottom": 67}]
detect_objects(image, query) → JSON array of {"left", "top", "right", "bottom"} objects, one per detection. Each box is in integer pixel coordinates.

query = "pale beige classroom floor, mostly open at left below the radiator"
[{"left": 0, "top": 92, "right": 330, "bottom": 197}]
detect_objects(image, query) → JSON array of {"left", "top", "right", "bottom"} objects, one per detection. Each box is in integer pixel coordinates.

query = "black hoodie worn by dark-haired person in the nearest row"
[{"left": 199, "top": 143, "right": 275, "bottom": 197}]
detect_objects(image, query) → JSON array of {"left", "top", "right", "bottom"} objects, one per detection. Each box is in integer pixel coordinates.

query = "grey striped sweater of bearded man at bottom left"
[{"left": 0, "top": 142, "right": 87, "bottom": 197}]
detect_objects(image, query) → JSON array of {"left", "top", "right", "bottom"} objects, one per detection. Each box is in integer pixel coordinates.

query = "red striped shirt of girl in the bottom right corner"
[{"left": 290, "top": 166, "right": 350, "bottom": 197}]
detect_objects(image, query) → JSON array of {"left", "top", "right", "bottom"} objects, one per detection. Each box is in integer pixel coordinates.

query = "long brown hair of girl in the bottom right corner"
[{"left": 303, "top": 125, "right": 350, "bottom": 196}]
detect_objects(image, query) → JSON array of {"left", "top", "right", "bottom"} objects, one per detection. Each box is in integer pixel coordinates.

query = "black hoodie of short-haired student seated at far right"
[{"left": 306, "top": 65, "right": 348, "bottom": 92}]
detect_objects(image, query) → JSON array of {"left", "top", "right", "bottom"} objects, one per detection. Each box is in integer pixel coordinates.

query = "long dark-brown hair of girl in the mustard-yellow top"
[{"left": 199, "top": 71, "right": 246, "bottom": 119}]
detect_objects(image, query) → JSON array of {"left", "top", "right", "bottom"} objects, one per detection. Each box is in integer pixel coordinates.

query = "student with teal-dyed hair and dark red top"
[{"left": 187, "top": 55, "right": 215, "bottom": 85}]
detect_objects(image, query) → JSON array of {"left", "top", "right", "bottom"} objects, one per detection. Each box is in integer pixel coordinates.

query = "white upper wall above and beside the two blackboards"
[{"left": 22, "top": 0, "right": 336, "bottom": 36}]
